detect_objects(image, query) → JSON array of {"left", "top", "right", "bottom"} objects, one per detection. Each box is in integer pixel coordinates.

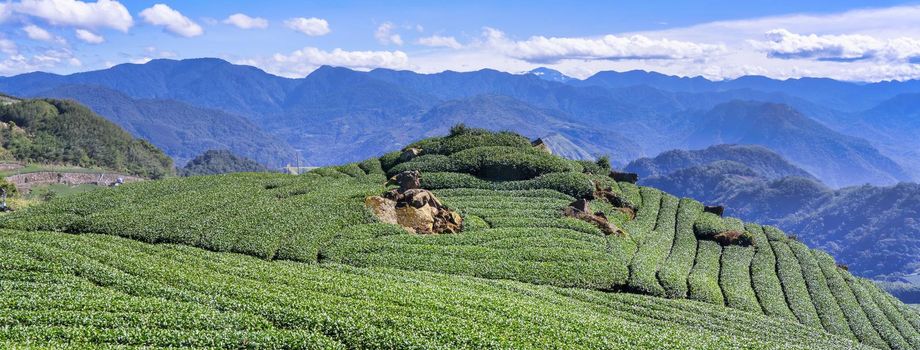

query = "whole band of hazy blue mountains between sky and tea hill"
[{"left": 0, "top": 59, "right": 920, "bottom": 187}]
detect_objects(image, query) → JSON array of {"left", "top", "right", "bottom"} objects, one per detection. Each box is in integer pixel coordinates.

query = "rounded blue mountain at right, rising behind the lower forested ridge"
[{"left": 685, "top": 101, "right": 911, "bottom": 187}]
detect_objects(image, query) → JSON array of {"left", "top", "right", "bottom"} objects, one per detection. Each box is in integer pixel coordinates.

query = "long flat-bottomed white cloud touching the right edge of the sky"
[{"left": 750, "top": 29, "right": 920, "bottom": 61}]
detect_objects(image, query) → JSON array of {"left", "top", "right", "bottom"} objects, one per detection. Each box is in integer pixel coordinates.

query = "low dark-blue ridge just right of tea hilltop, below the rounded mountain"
[{"left": 626, "top": 145, "right": 817, "bottom": 180}]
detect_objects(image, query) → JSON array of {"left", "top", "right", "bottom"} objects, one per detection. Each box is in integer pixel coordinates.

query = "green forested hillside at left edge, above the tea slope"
[{"left": 0, "top": 99, "right": 174, "bottom": 178}]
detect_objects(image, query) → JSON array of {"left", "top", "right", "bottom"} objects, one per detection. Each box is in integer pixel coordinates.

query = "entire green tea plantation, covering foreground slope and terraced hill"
[{"left": 0, "top": 129, "right": 920, "bottom": 349}]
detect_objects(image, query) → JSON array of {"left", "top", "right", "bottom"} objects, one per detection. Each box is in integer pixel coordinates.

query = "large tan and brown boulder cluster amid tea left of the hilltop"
[{"left": 364, "top": 171, "right": 463, "bottom": 234}]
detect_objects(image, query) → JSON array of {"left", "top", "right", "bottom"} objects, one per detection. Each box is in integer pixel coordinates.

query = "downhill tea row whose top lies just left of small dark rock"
[{"left": 658, "top": 198, "right": 703, "bottom": 298}]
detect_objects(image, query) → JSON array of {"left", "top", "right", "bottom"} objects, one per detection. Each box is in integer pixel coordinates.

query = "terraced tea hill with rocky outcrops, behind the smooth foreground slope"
[{"left": 0, "top": 129, "right": 920, "bottom": 349}]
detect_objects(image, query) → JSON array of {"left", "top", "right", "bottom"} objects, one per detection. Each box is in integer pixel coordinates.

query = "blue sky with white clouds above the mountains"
[{"left": 0, "top": 0, "right": 920, "bottom": 81}]
